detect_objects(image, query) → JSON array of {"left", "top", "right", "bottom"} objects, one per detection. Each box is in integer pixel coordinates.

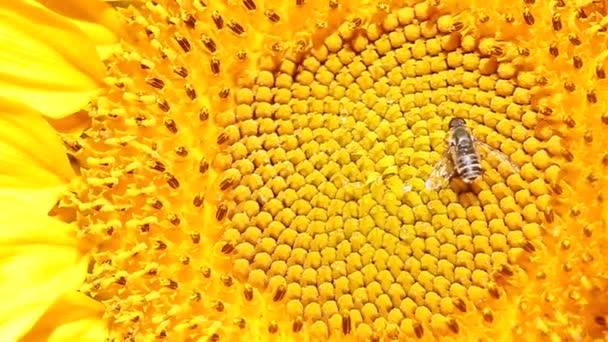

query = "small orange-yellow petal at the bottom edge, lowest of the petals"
[{"left": 21, "top": 291, "right": 108, "bottom": 342}]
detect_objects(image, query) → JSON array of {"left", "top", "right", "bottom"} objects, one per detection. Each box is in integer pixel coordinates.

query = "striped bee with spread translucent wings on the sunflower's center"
[{"left": 425, "top": 118, "right": 519, "bottom": 190}]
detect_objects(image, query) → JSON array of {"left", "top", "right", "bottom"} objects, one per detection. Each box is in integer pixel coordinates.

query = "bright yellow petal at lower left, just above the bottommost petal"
[{"left": 0, "top": 207, "right": 87, "bottom": 341}]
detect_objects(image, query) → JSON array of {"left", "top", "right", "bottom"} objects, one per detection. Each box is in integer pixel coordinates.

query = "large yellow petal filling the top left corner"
[{"left": 0, "top": 0, "right": 104, "bottom": 118}]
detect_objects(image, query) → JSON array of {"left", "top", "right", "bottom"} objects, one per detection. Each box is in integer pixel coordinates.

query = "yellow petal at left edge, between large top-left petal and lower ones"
[{"left": 0, "top": 97, "right": 74, "bottom": 213}]
